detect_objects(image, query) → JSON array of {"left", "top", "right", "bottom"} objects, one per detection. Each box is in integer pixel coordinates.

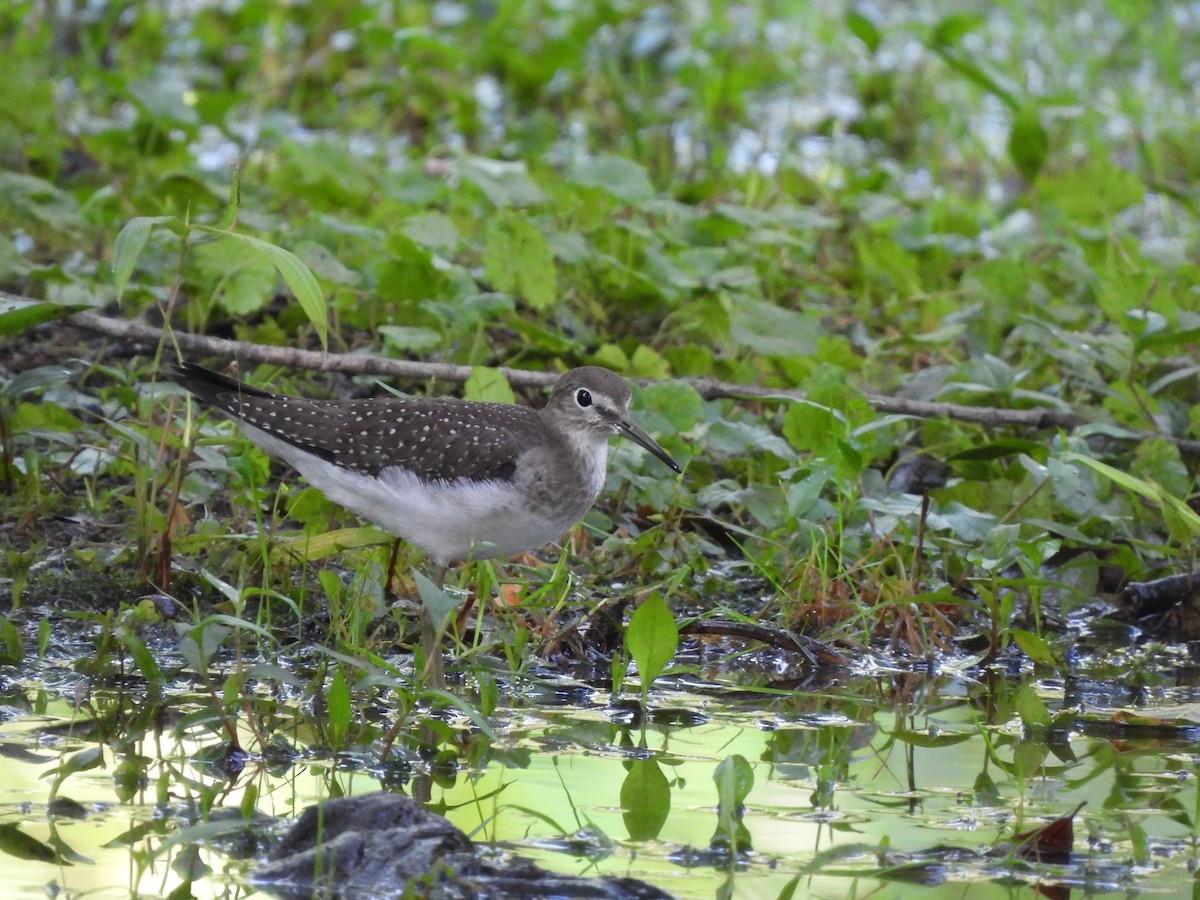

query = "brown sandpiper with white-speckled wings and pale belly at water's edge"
[{"left": 167, "top": 364, "right": 680, "bottom": 681}]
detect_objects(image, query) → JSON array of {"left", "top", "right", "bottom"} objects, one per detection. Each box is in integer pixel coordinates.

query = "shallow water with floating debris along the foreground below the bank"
[{"left": 0, "top": 619, "right": 1200, "bottom": 898}]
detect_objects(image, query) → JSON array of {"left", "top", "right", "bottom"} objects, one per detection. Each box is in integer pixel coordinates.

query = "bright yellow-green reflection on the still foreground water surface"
[{"left": 0, "top": 692, "right": 1198, "bottom": 898}]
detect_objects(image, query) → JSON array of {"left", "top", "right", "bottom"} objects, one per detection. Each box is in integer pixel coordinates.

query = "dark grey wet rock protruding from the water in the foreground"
[{"left": 252, "top": 792, "right": 670, "bottom": 900}]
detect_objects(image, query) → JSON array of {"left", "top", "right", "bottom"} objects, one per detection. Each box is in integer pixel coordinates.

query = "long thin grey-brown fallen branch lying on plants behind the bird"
[{"left": 25, "top": 309, "right": 1200, "bottom": 454}]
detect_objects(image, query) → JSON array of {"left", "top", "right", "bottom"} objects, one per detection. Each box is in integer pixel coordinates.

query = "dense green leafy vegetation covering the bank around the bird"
[{"left": 0, "top": 0, "right": 1200, "bottom": 897}]
